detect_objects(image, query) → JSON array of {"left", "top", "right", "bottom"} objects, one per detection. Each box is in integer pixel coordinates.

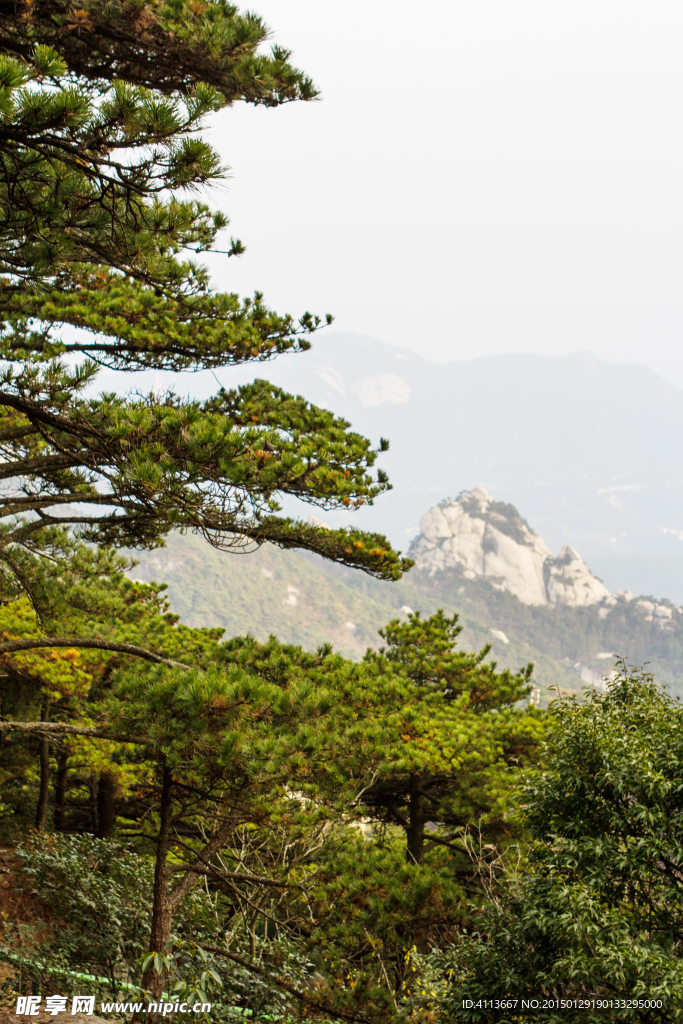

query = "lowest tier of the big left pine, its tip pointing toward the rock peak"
[{"left": 0, "top": 364, "right": 411, "bottom": 579}]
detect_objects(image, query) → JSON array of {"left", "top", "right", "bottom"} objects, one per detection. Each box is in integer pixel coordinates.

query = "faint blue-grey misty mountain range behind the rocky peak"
[{"left": 214, "top": 334, "right": 683, "bottom": 600}]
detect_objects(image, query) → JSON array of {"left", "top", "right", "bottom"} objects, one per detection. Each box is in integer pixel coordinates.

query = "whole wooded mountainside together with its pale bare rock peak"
[{"left": 132, "top": 488, "right": 683, "bottom": 701}]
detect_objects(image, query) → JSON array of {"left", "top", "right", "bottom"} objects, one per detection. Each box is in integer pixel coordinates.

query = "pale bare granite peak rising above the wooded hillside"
[{"left": 410, "top": 487, "right": 609, "bottom": 607}]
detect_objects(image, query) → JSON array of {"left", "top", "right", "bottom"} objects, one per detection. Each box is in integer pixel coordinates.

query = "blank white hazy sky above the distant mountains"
[{"left": 198, "top": 0, "right": 683, "bottom": 387}]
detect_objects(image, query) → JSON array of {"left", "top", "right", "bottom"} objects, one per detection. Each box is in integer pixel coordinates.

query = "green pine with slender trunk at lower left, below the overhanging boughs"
[{"left": 0, "top": 557, "right": 331, "bottom": 997}]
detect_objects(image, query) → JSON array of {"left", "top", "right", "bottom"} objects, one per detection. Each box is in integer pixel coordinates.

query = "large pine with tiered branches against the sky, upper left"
[{"left": 0, "top": 0, "right": 409, "bottom": 579}]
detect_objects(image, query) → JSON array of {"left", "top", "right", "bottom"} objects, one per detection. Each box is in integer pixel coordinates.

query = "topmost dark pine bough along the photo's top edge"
[{"left": 0, "top": 0, "right": 316, "bottom": 106}]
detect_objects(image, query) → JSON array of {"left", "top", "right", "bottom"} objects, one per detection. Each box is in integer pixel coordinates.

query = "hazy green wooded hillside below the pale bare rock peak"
[{"left": 133, "top": 487, "right": 683, "bottom": 699}]
